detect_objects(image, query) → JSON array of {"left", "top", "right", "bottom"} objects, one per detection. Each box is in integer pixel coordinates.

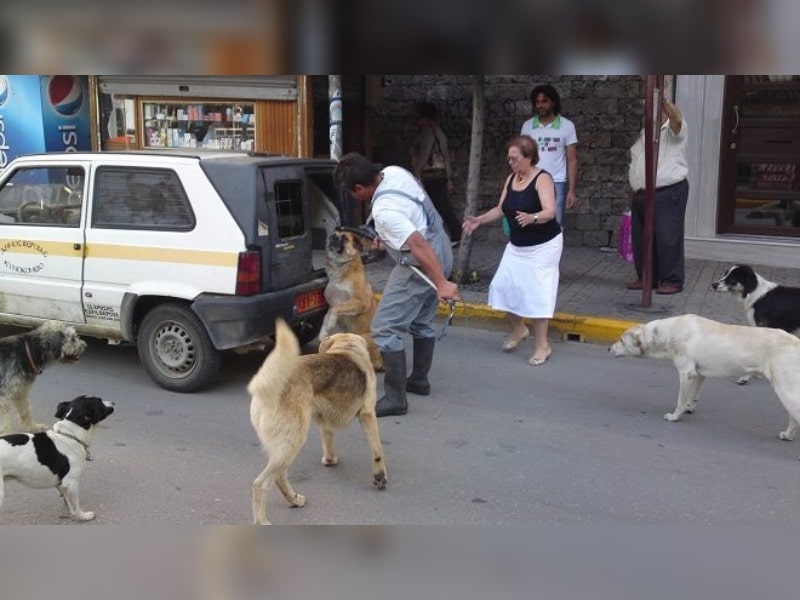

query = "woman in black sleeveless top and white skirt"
[{"left": 463, "top": 135, "right": 564, "bottom": 366}]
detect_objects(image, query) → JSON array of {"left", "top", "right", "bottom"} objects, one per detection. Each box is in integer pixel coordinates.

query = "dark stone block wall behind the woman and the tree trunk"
[{"left": 373, "top": 75, "right": 644, "bottom": 247}]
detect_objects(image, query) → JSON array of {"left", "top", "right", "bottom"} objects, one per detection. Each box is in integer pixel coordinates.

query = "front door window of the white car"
[{"left": 0, "top": 167, "right": 85, "bottom": 227}]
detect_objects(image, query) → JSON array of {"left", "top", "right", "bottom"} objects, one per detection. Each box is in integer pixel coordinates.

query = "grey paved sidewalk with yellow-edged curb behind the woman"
[{"left": 365, "top": 241, "right": 800, "bottom": 344}]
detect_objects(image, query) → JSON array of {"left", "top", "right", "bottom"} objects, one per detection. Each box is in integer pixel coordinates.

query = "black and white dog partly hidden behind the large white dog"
[{"left": 711, "top": 265, "right": 800, "bottom": 384}]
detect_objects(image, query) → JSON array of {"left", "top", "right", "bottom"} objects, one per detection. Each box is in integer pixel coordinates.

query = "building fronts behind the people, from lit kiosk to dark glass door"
[{"left": 84, "top": 75, "right": 800, "bottom": 266}]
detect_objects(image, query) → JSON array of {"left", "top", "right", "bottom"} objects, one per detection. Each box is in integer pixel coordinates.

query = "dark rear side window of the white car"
[{"left": 92, "top": 168, "right": 195, "bottom": 231}]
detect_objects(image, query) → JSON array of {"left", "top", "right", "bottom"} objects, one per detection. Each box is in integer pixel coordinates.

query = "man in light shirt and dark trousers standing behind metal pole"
[{"left": 627, "top": 98, "right": 689, "bottom": 294}]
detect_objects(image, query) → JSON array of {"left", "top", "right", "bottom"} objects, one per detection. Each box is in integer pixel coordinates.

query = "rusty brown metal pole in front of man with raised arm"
[{"left": 642, "top": 75, "right": 664, "bottom": 308}]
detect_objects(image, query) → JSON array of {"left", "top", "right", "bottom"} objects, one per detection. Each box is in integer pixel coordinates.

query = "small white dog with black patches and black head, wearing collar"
[{"left": 0, "top": 396, "right": 114, "bottom": 521}]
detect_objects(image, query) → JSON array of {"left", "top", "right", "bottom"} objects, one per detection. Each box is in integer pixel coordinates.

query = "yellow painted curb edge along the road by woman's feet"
[{"left": 376, "top": 294, "right": 640, "bottom": 344}]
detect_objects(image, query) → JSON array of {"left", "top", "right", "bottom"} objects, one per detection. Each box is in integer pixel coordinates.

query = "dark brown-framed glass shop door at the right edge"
[{"left": 717, "top": 75, "right": 800, "bottom": 237}]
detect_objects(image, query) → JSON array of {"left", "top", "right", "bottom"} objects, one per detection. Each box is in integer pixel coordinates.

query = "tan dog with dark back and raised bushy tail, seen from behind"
[{"left": 247, "top": 319, "right": 388, "bottom": 525}]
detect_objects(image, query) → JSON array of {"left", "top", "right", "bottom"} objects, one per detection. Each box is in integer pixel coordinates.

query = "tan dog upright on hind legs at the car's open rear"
[{"left": 319, "top": 230, "right": 383, "bottom": 371}]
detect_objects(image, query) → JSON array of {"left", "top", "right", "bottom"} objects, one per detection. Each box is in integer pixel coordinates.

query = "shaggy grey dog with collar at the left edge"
[{"left": 0, "top": 321, "right": 86, "bottom": 435}]
